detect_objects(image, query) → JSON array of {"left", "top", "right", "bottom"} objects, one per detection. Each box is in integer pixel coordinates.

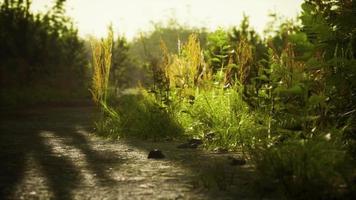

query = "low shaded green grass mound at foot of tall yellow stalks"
[{"left": 93, "top": 90, "right": 183, "bottom": 140}]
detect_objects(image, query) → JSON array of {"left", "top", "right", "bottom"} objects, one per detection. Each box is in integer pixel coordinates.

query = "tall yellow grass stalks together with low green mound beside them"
[{"left": 91, "top": 27, "right": 181, "bottom": 140}]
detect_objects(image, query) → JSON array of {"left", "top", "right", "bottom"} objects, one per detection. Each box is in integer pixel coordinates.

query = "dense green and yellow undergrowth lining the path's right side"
[{"left": 92, "top": 1, "right": 356, "bottom": 199}]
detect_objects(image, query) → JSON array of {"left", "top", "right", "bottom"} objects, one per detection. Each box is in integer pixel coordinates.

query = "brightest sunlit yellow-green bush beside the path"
[{"left": 177, "top": 89, "right": 263, "bottom": 150}]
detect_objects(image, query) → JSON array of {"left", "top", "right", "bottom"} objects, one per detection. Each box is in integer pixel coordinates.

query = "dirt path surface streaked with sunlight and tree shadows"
[{"left": 0, "top": 107, "right": 255, "bottom": 199}]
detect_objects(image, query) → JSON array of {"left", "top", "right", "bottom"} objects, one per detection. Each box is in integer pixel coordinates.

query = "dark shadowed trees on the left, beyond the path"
[{"left": 0, "top": 0, "right": 87, "bottom": 104}]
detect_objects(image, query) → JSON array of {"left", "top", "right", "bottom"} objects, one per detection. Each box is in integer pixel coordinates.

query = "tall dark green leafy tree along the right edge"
[{"left": 301, "top": 0, "right": 356, "bottom": 157}]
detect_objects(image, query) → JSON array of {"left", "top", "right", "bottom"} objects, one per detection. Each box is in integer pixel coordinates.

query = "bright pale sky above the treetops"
[{"left": 32, "top": 0, "right": 303, "bottom": 39}]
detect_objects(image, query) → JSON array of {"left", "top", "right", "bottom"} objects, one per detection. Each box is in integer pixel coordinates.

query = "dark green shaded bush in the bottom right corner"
[{"left": 253, "top": 138, "right": 354, "bottom": 199}]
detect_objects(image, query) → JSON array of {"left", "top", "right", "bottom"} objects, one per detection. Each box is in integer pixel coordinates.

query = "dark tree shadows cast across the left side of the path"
[{"left": 0, "top": 107, "right": 122, "bottom": 199}]
